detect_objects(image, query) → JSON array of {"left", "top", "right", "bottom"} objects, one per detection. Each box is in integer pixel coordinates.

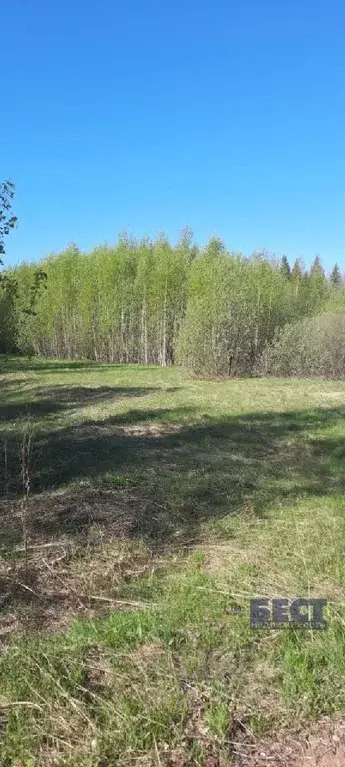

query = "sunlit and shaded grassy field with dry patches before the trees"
[{"left": 0, "top": 359, "right": 345, "bottom": 767}]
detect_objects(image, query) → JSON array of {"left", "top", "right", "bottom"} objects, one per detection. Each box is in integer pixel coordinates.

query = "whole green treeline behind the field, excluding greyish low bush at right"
[{"left": 0, "top": 230, "right": 345, "bottom": 376}]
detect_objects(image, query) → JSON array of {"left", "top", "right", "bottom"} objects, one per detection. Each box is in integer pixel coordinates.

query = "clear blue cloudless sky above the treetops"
[{"left": 0, "top": 0, "right": 345, "bottom": 269}]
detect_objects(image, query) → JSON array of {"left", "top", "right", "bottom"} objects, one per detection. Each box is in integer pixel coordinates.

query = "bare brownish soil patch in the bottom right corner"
[{"left": 230, "top": 718, "right": 345, "bottom": 767}]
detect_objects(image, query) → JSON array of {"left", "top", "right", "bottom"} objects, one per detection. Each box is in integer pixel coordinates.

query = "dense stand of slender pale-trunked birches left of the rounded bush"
[{"left": 6, "top": 235, "right": 188, "bottom": 366}]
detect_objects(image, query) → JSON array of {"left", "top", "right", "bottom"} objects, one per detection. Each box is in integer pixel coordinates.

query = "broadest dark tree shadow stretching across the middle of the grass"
[{"left": 1, "top": 402, "right": 345, "bottom": 549}]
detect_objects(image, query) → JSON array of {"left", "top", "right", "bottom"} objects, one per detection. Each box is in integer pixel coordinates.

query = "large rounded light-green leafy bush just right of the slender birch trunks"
[{"left": 178, "top": 244, "right": 314, "bottom": 376}]
